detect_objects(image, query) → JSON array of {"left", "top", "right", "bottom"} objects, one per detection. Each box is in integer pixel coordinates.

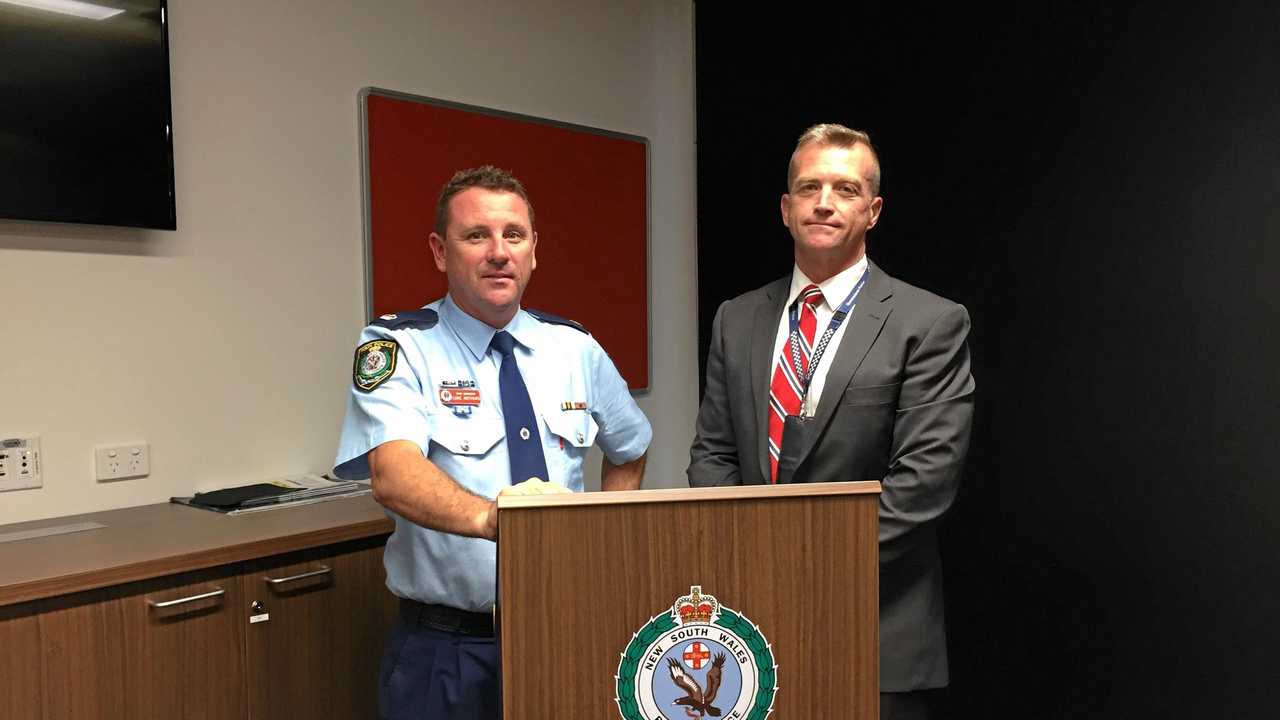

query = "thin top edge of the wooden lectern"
[{"left": 498, "top": 480, "right": 881, "bottom": 510}]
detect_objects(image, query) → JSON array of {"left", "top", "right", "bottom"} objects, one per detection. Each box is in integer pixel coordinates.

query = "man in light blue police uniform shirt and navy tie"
[{"left": 334, "top": 165, "right": 653, "bottom": 720}]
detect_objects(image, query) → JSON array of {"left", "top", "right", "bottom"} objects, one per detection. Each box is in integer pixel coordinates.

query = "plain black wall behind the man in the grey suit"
[{"left": 696, "top": 3, "right": 1280, "bottom": 719}]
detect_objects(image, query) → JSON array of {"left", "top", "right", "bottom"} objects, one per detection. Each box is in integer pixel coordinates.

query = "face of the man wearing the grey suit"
[{"left": 782, "top": 143, "right": 883, "bottom": 268}]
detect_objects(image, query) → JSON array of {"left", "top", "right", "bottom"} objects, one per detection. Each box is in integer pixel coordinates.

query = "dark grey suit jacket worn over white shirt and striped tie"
[{"left": 689, "top": 264, "right": 974, "bottom": 692}]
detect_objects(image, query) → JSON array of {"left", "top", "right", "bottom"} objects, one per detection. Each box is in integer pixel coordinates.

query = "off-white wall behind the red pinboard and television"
[{"left": 0, "top": 0, "right": 698, "bottom": 523}]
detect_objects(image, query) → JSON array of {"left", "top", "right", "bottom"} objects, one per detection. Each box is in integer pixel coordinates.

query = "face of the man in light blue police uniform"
[{"left": 430, "top": 187, "right": 538, "bottom": 328}]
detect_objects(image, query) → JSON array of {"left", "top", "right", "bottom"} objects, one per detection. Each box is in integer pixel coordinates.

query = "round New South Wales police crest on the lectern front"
[{"left": 614, "top": 585, "right": 778, "bottom": 720}]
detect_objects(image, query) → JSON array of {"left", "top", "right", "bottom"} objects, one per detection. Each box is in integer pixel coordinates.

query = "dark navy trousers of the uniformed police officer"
[{"left": 378, "top": 602, "right": 502, "bottom": 720}]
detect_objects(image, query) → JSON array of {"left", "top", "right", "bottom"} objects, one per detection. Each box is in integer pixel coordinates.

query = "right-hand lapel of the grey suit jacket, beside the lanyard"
[{"left": 797, "top": 261, "right": 893, "bottom": 465}]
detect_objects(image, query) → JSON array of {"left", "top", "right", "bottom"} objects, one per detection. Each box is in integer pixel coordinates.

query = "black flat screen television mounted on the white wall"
[{"left": 0, "top": 0, "right": 177, "bottom": 229}]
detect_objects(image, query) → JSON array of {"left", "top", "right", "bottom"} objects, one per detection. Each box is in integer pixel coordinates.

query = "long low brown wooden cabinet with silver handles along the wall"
[{"left": 0, "top": 501, "right": 397, "bottom": 720}]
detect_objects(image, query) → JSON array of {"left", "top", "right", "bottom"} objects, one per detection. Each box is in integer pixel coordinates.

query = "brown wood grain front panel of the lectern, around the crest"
[{"left": 499, "top": 493, "right": 879, "bottom": 719}]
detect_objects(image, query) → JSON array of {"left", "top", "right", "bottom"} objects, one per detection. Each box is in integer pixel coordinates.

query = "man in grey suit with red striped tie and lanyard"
[{"left": 689, "top": 124, "right": 974, "bottom": 720}]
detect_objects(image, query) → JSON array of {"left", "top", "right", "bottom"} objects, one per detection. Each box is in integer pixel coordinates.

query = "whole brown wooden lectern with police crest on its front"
[{"left": 497, "top": 482, "right": 879, "bottom": 720}]
